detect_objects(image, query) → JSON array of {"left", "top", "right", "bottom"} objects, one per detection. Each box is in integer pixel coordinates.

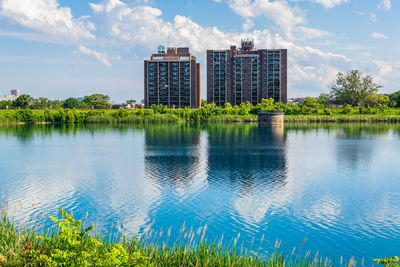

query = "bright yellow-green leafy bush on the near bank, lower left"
[{"left": 37, "top": 209, "right": 147, "bottom": 266}]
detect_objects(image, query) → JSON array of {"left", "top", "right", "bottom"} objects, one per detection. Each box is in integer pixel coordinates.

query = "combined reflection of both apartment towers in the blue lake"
[{"left": 145, "top": 124, "right": 287, "bottom": 227}]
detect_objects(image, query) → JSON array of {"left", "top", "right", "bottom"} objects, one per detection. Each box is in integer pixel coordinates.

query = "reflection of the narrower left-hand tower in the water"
[{"left": 144, "top": 124, "right": 208, "bottom": 199}]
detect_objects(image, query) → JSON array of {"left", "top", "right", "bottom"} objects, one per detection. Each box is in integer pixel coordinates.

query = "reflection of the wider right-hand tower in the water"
[{"left": 208, "top": 124, "right": 288, "bottom": 224}]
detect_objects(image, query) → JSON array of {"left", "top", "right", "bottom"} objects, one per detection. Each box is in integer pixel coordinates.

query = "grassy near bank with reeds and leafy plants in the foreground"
[{"left": 0, "top": 210, "right": 372, "bottom": 267}]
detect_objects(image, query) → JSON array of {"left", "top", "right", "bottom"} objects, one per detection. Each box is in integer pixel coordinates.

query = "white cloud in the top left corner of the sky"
[{"left": 0, "top": 0, "right": 96, "bottom": 40}]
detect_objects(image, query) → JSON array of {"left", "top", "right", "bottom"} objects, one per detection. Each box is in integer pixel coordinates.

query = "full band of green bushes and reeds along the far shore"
[{"left": 0, "top": 101, "right": 400, "bottom": 124}]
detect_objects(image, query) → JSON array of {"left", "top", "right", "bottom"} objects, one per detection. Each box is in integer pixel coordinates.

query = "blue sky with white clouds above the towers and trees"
[{"left": 0, "top": 0, "right": 400, "bottom": 103}]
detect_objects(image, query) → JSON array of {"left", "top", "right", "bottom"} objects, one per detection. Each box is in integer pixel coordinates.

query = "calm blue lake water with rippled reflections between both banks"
[{"left": 0, "top": 124, "right": 400, "bottom": 265}]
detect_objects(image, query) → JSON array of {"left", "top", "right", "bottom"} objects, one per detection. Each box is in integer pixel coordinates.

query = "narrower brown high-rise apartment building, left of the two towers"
[{"left": 144, "top": 46, "right": 201, "bottom": 108}]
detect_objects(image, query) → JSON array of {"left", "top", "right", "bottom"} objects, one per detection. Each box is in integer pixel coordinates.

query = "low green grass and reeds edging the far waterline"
[{"left": 0, "top": 106, "right": 400, "bottom": 124}]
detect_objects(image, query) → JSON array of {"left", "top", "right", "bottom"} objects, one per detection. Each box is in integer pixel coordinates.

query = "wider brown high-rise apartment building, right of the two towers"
[{"left": 207, "top": 40, "right": 287, "bottom": 106}]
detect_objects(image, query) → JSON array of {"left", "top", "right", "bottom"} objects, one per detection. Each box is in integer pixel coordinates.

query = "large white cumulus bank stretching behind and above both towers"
[{"left": 86, "top": 0, "right": 400, "bottom": 95}]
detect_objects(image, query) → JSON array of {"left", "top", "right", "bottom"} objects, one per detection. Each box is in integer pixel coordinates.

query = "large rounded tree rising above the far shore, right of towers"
[{"left": 331, "top": 70, "right": 382, "bottom": 107}]
